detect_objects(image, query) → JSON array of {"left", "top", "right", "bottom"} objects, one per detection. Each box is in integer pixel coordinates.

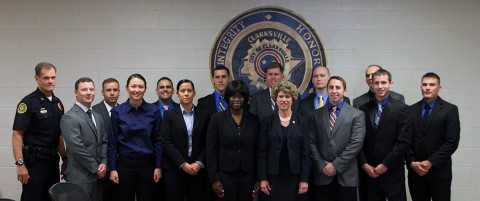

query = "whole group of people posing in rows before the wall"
[{"left": 12, "top": 62, "right": 460, "bottom": 201}]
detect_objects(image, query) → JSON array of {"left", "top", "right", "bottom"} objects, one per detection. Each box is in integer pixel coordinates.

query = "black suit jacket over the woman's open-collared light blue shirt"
[{"left": 160, "top": 106, "right": 209, "bottom": 169}]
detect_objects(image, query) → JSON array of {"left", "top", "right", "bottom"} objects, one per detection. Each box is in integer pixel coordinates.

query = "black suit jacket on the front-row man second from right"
[{"left": 358, "top": 98, "right": 410, "bottom": 181}]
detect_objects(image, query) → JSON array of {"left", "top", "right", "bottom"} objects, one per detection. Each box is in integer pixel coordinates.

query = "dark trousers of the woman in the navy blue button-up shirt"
[{"left": 113, "top": 156, "right": 155, "bottom": 201}]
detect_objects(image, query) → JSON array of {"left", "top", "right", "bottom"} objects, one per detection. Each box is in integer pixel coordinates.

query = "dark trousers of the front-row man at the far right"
[{"left": 408, "top": 170, "right": 452, "bottom": 201}]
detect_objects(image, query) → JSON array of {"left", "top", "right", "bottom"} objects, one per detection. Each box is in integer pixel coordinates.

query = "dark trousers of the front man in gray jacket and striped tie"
[{"left": 310, "top": 173, "right": 357, "bottom": 201}]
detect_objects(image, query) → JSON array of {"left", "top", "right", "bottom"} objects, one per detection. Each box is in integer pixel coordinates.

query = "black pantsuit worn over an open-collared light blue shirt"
[{"left": 160, "top": 106, "right": 210, "bottom": 201}]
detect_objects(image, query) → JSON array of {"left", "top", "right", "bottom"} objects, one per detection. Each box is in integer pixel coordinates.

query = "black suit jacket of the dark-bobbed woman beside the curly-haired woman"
[{"left": 207, "top": 110, "right": 260, "bottom": 182}]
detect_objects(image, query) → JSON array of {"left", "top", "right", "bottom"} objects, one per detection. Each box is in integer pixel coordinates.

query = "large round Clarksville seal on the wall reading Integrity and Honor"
[{"left": 210, "top": 7, "right": 326, "bottom": 97}]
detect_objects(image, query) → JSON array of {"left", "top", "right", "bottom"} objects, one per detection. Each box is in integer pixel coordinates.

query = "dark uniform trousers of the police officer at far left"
[{"left": 20, "top": 155, "right": 60, "bottom": 201}]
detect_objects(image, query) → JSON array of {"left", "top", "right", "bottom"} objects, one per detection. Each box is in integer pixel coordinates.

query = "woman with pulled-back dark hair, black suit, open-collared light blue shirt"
[{"left": 160, "top": 79, "right": 209, "bottom": 201}]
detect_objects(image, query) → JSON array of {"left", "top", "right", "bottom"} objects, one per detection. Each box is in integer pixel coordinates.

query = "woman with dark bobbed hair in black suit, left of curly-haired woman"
[{"left": 207, "top": 80, "right": 259, "bottom": 201}]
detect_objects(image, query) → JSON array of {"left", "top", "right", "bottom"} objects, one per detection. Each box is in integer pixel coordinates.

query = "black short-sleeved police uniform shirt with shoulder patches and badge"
[{"left": 13, "top": 88, "right": 64, "bottom": 147}]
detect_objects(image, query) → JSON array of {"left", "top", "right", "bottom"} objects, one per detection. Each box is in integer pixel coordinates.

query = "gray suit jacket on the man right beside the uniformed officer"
[{"left": 60, "top": 104, "right": 107, "bottom": 183}]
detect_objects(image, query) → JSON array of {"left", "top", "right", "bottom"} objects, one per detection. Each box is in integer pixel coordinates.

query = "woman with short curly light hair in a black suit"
[{"left": 258, "top": 81, "right": 310, "bottom": 201}]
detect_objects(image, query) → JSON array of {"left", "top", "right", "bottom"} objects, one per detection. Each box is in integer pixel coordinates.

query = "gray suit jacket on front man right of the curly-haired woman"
[{"left": 309, "top": 104, "right": 365, "bottom": 187}]
